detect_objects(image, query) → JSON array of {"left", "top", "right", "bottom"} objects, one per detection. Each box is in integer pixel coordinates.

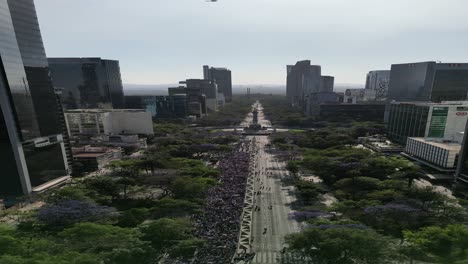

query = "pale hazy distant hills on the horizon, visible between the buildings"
[{"left": 124, "top": 83, "right": 364, "bottom": 95}]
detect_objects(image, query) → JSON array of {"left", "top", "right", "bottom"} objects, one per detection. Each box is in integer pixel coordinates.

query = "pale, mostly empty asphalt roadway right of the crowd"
[{"left": 250, "top": 101, "right": 300, "bottom": 264}]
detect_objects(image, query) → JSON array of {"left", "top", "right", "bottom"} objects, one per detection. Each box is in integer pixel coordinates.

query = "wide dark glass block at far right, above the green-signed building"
[{"left": 388, "top": 61, "right": 468, "bottom": 102}]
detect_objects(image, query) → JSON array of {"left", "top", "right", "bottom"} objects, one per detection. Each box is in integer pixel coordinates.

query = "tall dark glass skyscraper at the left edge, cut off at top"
[{"left": 0, "top": 0, "right": 69, "bottom": 196}]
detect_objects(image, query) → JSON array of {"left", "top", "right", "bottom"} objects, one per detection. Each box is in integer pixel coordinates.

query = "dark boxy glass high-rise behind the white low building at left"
[{"left": 48, "top": 58, "right": 124, "bottom": 109}]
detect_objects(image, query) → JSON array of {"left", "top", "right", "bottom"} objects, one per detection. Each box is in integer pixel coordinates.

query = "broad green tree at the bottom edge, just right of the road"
[{"left": 286, "top": 224, "right": 395, "bottom": 264}]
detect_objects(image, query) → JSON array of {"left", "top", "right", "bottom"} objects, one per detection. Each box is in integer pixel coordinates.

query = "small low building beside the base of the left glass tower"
[{"left": 72, "top": 146, "right": 122, "bottom": 172}]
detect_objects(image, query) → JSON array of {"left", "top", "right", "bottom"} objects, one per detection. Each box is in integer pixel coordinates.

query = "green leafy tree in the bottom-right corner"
[{"left": 404, "top": 225, "right": 468, "bottom": 264}]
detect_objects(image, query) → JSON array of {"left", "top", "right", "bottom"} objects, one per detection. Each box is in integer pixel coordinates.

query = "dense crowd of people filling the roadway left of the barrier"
[{"left": 193, "top": 142, "right": 250, "bottom": 264}]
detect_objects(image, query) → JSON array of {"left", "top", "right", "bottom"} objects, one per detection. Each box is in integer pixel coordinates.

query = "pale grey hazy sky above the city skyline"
[{"left": 35, "top": 0, "right": 468, "bottom": 84}]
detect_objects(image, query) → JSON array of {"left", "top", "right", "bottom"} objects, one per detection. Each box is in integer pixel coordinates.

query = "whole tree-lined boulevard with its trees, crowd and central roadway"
[{"left": 0, "top": 96, "right": 468, "bottom": 264}]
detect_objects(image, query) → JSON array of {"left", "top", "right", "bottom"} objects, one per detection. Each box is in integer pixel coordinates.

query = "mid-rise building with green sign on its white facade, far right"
[{"left": 387, "top": 101, "right": 468, "bottom": 145}]
